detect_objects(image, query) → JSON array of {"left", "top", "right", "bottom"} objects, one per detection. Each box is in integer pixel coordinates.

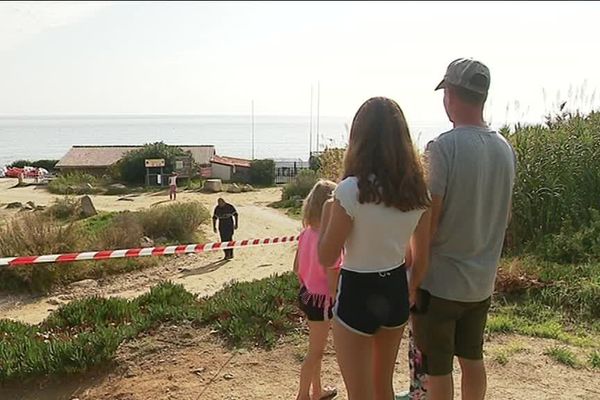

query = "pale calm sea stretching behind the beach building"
[{"left": 0, "top": 115, "right": 448, "bottom": 166}]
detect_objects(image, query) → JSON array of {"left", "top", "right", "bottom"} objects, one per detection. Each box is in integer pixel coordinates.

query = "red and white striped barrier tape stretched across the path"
[{"left": 0, "top": 236, "right": 298, "bottom": 267}]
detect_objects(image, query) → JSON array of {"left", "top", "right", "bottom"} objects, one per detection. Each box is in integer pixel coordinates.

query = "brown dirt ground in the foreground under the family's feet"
[{"left": 0, "top": 326, "right": 600, "bottom": 400}]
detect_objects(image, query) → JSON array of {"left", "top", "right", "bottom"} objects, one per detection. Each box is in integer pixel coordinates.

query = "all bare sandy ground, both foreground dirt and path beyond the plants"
[{"left": 0, "top": 180, "right": 600, "bottom": 400}]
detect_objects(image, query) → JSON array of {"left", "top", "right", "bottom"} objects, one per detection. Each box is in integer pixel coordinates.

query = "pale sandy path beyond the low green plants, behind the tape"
[{"left": 0, "top": 180, "right": 300, "bottom": 323}]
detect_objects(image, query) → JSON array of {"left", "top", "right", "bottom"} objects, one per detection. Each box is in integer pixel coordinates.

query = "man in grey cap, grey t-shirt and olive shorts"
[{"left": 413, "top": 58, "right": 516, "bottom": 400}]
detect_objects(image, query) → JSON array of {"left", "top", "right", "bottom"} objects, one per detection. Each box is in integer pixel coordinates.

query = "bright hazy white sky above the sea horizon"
[{"left": 0, "top": 2, "right": 600, "bottom": 125}]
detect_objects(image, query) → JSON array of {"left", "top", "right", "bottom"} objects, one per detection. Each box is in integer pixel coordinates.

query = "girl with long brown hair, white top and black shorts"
[{"left": 319, "top": 97, "right": 430, "bottom": 400}]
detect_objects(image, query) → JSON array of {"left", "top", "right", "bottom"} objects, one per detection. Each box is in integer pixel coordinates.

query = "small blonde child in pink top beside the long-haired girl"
[{"left": 294, "top": 180, "right": 341, "bottom": 400}]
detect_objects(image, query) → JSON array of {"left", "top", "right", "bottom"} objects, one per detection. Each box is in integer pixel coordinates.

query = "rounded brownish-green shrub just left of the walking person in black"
[{"left": 138, "top": 202, "right": 210, "bottom": 242}]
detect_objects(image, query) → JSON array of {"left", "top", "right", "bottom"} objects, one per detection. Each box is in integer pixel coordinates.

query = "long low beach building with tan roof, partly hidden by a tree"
[{"left": 55, "top": 145, "right": 215, "bottom": 176}]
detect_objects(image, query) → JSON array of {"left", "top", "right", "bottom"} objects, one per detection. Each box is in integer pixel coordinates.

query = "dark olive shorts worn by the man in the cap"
[{"left": 411, "top": 289, "right": 491, "bottom": 376}]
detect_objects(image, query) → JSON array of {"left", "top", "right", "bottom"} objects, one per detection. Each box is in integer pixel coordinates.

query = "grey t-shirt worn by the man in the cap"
[{"left": 421, "top": 126, "right": 516, "bottom": 302}]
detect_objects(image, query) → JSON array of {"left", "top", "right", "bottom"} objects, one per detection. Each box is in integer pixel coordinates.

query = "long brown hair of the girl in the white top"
[{"left": 344, "top": 97, "right": 431, "bottom": 211}]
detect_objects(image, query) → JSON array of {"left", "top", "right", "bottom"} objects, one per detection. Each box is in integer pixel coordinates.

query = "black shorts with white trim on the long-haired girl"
[{"left": 333, "top": 264, "right": 409, "bottom": 335}]
